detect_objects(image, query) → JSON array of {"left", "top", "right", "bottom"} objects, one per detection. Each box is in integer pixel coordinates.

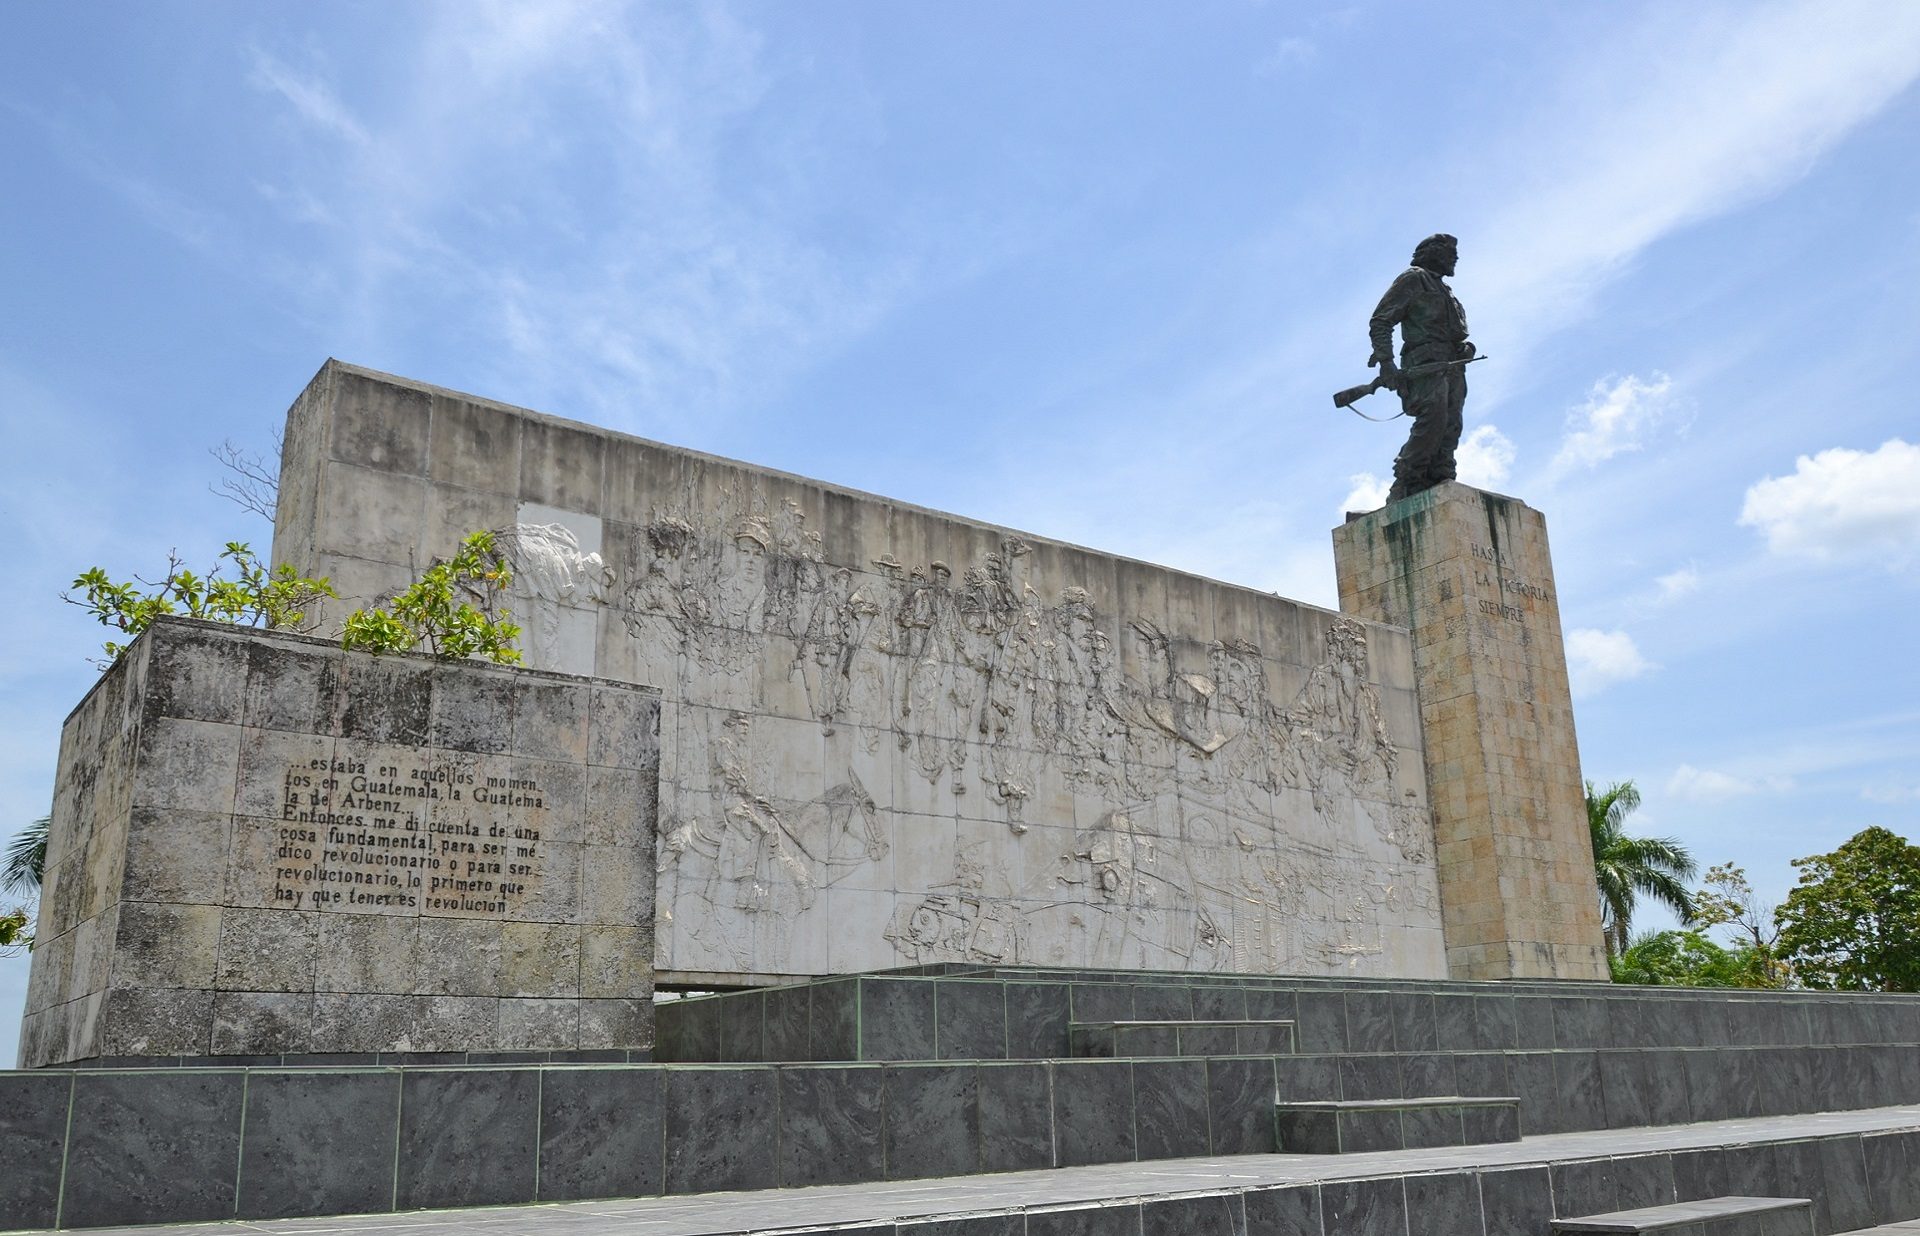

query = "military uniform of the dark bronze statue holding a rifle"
[{"left": 1367, "top": 267, "right": 1473, "bottom": 501}]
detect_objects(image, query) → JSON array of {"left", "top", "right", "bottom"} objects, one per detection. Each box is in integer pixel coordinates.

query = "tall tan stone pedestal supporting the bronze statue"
[{"left": 1332, "top": 484, "right": 1607, "bottom": 981}]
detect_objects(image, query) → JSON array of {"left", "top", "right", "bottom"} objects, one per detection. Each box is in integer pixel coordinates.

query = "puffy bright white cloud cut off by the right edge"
[{"left": 1740, "top": 438, "right": 1920, "bottom": 566}]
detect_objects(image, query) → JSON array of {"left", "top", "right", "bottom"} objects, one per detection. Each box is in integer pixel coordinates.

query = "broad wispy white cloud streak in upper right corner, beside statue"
[{"left": 1471, "top": 0, "right": 1920, "bottom": 357}]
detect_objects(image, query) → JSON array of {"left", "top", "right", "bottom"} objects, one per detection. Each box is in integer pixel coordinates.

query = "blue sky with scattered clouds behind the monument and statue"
[{"left": 0, "top": 0, "right": 1920, "bottom": 1058}]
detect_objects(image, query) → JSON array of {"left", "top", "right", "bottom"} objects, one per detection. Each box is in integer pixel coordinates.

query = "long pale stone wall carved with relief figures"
[{"left": 276, "top": 367, "right": 1446, "bottom": 981}]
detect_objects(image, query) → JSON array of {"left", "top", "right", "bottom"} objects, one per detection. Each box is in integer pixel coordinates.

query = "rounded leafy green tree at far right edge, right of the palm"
[{"left": 1778, "top": 827, "right": 1920, "bottom": 992}]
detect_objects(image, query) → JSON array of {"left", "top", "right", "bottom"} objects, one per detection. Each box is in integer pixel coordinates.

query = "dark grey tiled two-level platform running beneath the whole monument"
[{"left": 15, "top": 967, "right": 1920, "bottom": 1236}]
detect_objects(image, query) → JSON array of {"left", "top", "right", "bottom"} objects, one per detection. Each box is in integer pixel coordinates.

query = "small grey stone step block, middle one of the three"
[{"left": 1273, "top": 1094, "right": 1521, "bottom": 1155}]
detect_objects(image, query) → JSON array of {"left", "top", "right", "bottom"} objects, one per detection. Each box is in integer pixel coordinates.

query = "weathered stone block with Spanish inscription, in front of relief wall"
[{"left": 21, "top": 621, "right": 659, "bottom": 1065}]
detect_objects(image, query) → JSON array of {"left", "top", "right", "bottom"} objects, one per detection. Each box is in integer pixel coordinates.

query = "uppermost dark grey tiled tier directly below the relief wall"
[{"left": 655, "top": 969, "right": 1920, "bottom": 1059}]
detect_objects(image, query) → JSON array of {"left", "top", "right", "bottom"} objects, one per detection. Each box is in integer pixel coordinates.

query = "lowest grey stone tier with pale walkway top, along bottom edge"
[{"left": 22, "top": 1107, "right": 1920, "bottom": 1236}]
